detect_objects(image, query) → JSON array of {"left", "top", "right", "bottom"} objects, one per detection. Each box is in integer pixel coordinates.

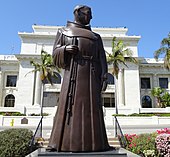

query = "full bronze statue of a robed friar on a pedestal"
[{"left": 48, "top": 5, "right": 110, "bottom": 152}]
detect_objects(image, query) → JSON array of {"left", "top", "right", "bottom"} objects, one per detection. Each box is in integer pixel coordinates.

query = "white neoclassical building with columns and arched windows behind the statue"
[{"left": 0, "top": 25, "right": 170, "bottom": 113}]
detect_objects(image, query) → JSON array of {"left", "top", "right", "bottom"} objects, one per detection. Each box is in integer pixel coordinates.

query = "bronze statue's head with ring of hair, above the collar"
[{"left": 74, "top": 5, "right": 92, "bottom": 25}]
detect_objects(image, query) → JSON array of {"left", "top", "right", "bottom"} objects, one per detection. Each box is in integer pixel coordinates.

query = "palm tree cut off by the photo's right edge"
[{"left": 154, "top": 33, "right": 170, "bottom": 70}]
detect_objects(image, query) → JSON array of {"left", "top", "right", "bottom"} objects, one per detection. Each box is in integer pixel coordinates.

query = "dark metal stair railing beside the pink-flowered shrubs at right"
[{"left": 114, "top": 116, "right": 127, "bottom": 148}]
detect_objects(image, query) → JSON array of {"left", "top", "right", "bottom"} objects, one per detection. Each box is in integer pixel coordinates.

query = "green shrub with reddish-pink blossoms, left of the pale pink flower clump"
[{"left": 125, "top": 133, "right": 158, "bottom": 155}]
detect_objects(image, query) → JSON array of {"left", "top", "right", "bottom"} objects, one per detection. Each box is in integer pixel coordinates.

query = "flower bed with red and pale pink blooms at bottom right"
[{"left": 125, "top": 128, "right": 170, "bottom": 157}]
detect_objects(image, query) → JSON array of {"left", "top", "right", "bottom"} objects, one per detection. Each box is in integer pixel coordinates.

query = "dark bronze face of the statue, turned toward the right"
[{"left": 76, "top": 7, "right": 92, "bottom": 25}]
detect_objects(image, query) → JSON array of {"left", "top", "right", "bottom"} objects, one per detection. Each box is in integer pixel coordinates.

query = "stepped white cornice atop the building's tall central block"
[{"left": 18, "top": 25, "right": 141, "bottom": 42}]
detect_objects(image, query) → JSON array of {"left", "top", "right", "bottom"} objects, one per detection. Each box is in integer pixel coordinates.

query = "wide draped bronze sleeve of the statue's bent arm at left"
[{"left": 52, "top": 29, "right": 67, "bottom": 69}]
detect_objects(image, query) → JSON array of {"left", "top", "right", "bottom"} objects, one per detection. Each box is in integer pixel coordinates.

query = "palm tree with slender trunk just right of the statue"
[{"left": 106, "top": 37, "right": 138, "bottom": 114}]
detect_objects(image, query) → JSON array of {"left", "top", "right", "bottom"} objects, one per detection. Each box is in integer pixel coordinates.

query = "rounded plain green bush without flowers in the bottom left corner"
[{"left": 0, "top": 128, "right": 33, "bottom": 157}]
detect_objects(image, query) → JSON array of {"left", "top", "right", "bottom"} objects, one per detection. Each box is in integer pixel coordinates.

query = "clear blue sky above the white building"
[{"left": 0, "top": 0, "right": 170, "bottom": 58}]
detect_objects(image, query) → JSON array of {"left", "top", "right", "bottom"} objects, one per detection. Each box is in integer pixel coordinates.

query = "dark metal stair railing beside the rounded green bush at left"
[{"left": 29, "top": 116, "right": 43, "bottom": 152}]
